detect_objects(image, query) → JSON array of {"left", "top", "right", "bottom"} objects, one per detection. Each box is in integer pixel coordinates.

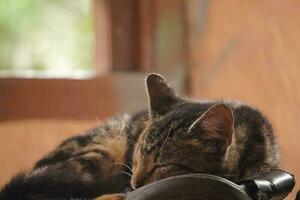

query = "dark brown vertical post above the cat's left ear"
[{"left": 110, "top": 0, "right": 140, "bottom": 71}]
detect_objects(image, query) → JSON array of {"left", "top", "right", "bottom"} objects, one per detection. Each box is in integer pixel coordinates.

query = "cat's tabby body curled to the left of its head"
[{"left": 0, "top": 113, "right": 147, "bottom": 200}]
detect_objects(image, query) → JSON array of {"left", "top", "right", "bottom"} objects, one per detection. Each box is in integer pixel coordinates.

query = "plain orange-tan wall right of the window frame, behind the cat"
[{"left": 188, "top": 0, "right": 300, "bottom": 199}]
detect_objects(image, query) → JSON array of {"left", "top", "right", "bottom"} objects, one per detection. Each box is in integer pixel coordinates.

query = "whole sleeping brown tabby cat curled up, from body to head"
[{"left": 0, "top": 73, "right": 279, "bottom": 200}]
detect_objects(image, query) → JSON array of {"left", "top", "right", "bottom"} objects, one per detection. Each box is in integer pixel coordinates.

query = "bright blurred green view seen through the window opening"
[{"left": 0, "top": 0, "right": 93, "bottom": 77}]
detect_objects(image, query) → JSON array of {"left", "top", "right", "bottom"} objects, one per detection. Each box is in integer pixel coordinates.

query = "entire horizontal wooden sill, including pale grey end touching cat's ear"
[{"left": 0, "top": 73, "right": 152, "bottom": 121}]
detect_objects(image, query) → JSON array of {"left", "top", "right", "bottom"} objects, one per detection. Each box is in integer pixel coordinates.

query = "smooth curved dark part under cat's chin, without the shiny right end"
[{"left": 126, "top": 174, "right": 250, "bottom": 200}]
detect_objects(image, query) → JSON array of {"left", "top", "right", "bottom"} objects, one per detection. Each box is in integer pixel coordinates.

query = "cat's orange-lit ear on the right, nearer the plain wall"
[{"left": 189, "top": 104, "right": 234, "bottom": 151}]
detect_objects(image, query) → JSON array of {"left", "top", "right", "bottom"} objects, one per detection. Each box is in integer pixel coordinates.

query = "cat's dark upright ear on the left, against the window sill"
[{"left": 146, "top": 73, "right": 178, "bottom": 116}]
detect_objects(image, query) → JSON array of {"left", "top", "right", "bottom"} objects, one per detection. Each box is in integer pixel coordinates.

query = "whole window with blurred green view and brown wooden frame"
[{"left": 0, "top": 0, "right": 188, "bottom": 121}]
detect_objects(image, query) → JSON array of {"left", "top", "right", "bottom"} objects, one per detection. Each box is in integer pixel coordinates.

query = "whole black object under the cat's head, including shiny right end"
[{"left": 126, "top": 170, "right": 295, "bottom": 200}]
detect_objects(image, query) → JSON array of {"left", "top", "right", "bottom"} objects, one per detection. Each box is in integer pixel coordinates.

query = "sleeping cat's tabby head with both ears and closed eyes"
[{"left": 131, "top": 74, "right": 234, "bottom": 188}]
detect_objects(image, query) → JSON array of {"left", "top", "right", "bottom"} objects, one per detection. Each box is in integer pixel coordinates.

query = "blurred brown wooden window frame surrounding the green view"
[{"left": 0, "top": 0, "right": 187, "bottom": 121}]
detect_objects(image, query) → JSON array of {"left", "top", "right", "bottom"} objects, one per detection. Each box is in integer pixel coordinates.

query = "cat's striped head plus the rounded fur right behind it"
[{"left": 131, "top": 74, "right": 279, "bottom": 188}]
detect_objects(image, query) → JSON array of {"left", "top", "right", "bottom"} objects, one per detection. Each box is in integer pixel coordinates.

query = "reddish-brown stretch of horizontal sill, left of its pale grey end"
[{"left": 0, "top": 76, "right": 118, "bottom": 121}]
